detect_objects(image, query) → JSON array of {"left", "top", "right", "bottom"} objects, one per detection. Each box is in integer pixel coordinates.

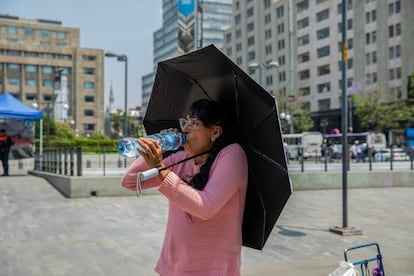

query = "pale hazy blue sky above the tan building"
[{"left": 0, "top": 0, "right": 162, "bottom": 109}]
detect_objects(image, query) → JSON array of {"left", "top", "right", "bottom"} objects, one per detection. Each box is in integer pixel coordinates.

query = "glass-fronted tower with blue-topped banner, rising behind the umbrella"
[{"left": 142, "top": 0, "right": 232, "bottom": 114}]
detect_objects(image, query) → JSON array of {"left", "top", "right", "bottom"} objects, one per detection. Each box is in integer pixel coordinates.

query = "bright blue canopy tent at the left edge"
[{"left": 0, "top": 92, "right": 43, "bottom": 160}]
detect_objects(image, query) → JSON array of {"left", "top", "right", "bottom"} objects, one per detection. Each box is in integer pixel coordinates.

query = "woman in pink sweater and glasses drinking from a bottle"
[{"left": 122, "top": 100, "right": 248, "bottom": 275}]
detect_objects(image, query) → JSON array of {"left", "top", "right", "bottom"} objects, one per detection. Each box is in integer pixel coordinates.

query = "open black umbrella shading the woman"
[{"left": 144, "top": 45, "right": 292, "bottom": 249}]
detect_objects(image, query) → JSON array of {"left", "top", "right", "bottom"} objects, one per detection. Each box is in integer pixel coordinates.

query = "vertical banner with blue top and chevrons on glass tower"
[{"left": 178, "top": 0, "right": 197, "bottom": 55}]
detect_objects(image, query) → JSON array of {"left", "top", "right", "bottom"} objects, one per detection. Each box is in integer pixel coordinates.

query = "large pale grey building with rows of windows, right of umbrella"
[{"left": 223, "top": 0, "right": 414, "bottom": 133}]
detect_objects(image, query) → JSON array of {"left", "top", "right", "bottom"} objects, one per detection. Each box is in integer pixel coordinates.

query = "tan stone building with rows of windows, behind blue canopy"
[{"left": 0, "top": 15, "right": 104, "bottom": 135}]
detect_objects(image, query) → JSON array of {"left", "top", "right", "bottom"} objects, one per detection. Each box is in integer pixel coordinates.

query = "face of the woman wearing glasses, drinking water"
[{"left": 182, "top": 116, "right": 221, "bottom": 155}]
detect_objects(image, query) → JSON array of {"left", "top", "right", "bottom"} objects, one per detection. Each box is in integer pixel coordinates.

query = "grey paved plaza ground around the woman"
[{"left": 0, "top": 175, "right": 414, "bottom": 276}]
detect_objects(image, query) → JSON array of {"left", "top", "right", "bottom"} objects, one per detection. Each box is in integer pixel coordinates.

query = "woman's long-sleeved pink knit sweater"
[{"left": 122, "top": 144, "right": 248, "bottom": 276}]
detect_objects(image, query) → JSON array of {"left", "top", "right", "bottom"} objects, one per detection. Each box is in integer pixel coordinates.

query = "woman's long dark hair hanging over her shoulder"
[{"left": 189, "top": 99, "right": 236, "bottom": 190}]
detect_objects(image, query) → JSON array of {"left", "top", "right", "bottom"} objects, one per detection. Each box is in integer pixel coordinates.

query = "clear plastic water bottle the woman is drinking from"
[{"left": 118, "top": 131, "right": 186, "bottom": 158}]
